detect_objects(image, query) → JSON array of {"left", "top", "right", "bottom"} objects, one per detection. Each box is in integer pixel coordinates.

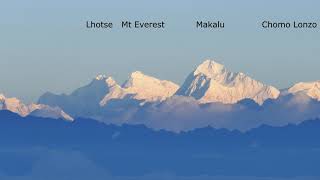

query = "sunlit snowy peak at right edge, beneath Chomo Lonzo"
[{"left": 287, "top": 81, "right": 320, "bottom": 101}]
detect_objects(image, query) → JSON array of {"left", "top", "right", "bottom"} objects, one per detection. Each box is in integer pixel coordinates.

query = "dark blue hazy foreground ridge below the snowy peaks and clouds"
[{"left": 0, "top": 111, "right": 320, "bottom": 177}]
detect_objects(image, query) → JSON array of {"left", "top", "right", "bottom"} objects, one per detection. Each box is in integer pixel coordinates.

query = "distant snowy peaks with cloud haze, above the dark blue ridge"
[{"left": 1, "top": 60, "right": 320, "bottom": 132}]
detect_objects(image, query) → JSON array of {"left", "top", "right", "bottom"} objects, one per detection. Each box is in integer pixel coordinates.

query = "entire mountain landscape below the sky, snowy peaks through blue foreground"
[{"left": 0, "top": 60, "right": 320, "bottom": 180}]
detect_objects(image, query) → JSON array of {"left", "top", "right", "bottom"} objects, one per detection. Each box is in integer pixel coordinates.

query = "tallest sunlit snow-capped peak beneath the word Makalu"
[{"left": 176, "top": 60, "right": 280, "bottom": 105}]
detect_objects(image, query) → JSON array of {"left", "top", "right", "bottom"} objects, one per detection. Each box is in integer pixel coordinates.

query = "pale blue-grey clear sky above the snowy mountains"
[{"left": 0, "top": 0, "right": 320, "bottom": 102}]
